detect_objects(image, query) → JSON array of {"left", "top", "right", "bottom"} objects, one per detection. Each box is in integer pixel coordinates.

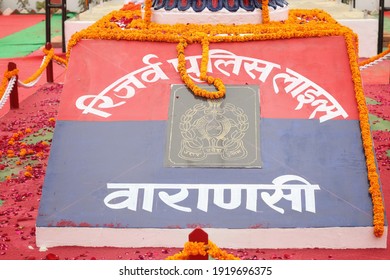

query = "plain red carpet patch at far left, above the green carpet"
[{"left": 0, "top": 14, "right": 45, "bottom": 39}]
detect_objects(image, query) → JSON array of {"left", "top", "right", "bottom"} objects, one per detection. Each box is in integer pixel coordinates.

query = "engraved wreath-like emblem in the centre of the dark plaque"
[{"left": 178, "top": 100, "right": 249, "bottom": 161}]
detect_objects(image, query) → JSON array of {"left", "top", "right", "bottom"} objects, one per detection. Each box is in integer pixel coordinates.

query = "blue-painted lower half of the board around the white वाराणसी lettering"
[{"left": 37, "top": 119, "right": 372, "bottom": 228}]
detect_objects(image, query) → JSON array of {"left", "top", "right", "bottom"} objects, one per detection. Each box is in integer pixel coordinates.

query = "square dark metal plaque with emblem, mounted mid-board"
[{"left": 165, "top": 85, "right": 261, "bottom": 168}]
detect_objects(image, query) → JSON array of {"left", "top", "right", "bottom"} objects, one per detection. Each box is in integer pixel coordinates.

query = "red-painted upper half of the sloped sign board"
[{"left": 58, "top": 37, "right": 357, "bottom": 121}]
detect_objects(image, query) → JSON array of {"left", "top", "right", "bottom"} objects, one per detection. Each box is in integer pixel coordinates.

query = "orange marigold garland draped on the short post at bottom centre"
[{"left": 166, "top": 240, "right": 240, "bottom": 260}]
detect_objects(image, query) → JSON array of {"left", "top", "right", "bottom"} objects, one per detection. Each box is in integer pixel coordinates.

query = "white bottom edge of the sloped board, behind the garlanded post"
[{"left": 36, "top": 226, "right": 388, "bottom": 249}]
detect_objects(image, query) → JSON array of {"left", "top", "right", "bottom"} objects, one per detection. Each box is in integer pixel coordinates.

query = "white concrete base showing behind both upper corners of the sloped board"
[{"left": 65, "top": 0, "right": 378, "bottom": 57}]
